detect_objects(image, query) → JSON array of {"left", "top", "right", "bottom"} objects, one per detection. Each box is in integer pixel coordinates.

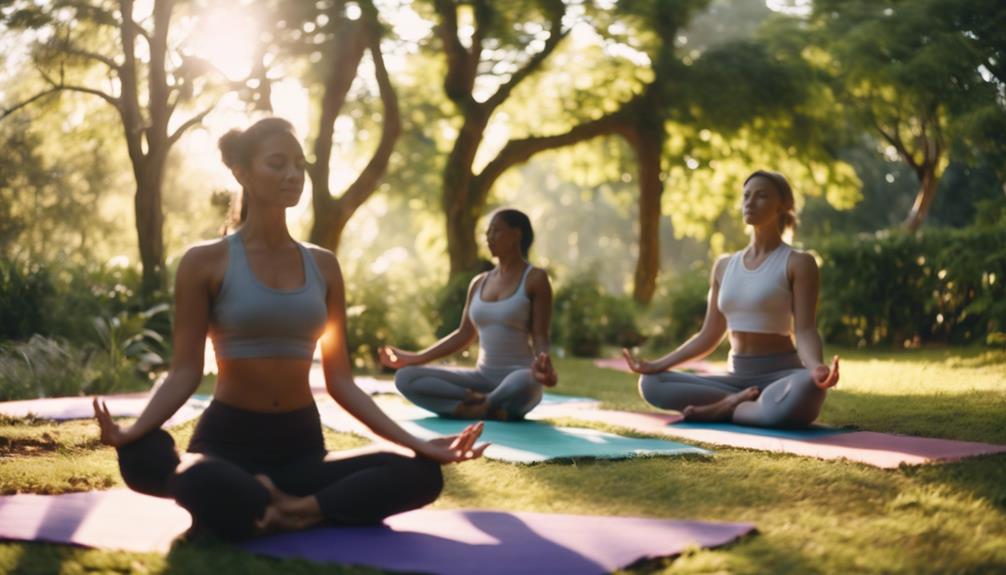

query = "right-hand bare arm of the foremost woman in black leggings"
[{"left": 316, "top": 251, "right": 485, "bottom": 462}]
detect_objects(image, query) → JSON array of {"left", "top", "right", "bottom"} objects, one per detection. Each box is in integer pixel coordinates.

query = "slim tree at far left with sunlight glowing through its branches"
[{"left": 0, "top": 0, "right": 225, "bottom": 298}]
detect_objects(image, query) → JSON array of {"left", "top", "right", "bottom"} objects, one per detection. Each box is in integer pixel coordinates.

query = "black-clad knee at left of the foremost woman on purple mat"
[{"left": 117, "top": 429, "right": 180, "bottom": 498}]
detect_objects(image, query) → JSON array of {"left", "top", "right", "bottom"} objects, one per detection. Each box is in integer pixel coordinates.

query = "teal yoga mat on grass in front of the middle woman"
[{"left": 398, "top": 417, "right": 711, "bottom": 463}]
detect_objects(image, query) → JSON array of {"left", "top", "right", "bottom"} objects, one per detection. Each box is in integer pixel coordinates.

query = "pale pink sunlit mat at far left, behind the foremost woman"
[{"left": 0, "top": 393, "right": 209, "bottom": 427}]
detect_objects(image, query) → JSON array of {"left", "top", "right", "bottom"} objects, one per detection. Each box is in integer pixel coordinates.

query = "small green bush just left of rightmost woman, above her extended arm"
[{"left": 647, "top": 266, "right": 709, "bottom": 354}]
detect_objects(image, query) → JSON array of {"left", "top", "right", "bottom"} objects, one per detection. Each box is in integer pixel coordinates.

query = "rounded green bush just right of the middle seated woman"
[{"left": 552, "top": 272, "right": 644, "bottom": 357}]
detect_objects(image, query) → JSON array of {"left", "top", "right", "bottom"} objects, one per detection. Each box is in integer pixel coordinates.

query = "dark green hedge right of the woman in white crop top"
[{"left": 816, "top": 226, "right": 1006, "bottom": 346}]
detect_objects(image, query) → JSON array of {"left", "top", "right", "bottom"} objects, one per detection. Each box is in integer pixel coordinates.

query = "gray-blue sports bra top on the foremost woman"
[{"left": 209, "top": 233, "right": 328, "bottom": 359}]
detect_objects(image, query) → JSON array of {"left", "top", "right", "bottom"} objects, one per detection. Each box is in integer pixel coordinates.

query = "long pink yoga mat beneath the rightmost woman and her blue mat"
[{"left": 549, "top": 406, "right": 1006, "bottom": 468}]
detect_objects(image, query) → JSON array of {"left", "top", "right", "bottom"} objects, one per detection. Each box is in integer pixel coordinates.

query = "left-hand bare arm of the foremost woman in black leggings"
[{"left": 95, "top": 246, "right": 212, "bottom": 447}]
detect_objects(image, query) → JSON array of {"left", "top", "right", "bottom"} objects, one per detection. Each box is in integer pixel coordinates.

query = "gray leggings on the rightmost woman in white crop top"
[{"left": 639, "top": 353, "right": 826, "bottom": 427}]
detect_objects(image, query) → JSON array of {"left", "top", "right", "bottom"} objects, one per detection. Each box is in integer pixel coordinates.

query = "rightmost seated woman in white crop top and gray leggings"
[{"left": 623, "top": 171, "right": 838, "bottom": 427}]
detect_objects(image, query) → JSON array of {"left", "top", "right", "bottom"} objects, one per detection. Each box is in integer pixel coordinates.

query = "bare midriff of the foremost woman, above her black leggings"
[{"left": 213, "top": 358, "right": 314, "bottom": 413}]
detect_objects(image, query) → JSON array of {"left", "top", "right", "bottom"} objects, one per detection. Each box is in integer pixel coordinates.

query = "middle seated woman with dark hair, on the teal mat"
[{"left": 380, "top": 209, "right": 558, "bottom": 420}]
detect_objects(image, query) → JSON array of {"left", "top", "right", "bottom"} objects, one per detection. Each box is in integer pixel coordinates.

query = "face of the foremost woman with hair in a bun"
[{"left": 235, "top": 133, "right": 305, "bottom": 208}]
